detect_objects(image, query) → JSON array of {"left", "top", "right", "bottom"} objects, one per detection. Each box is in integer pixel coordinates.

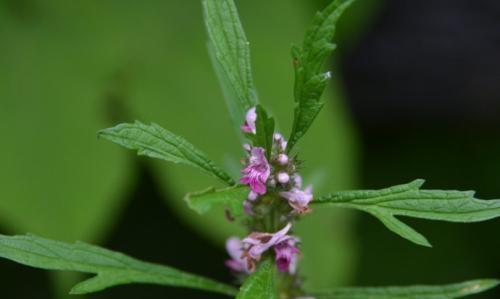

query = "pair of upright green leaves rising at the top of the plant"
[{"left": 203, "top": 0, "right": 352, "bottom": 151}]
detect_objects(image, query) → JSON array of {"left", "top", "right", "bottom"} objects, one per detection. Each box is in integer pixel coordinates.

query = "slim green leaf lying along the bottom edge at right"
[{"left": 312, "top": 279, "right": 500, "bottom": 299}]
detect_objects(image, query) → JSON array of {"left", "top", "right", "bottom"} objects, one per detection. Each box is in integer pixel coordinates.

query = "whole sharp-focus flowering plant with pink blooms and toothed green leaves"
[{"left": 0, "top": 0, "right": 500, "bottom": 299}]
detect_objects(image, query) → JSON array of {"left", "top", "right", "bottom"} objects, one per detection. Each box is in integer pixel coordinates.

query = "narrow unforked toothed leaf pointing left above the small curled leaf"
[{"left": 98, "top": 121, "right": 234, "bottom": 185}]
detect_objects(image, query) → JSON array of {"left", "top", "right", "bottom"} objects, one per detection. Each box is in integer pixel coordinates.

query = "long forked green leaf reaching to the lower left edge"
[{"left": 0, "top": 235, "right": 236, "bottom": 295}]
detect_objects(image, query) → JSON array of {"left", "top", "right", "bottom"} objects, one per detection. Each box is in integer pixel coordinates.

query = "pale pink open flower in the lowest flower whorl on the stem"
[{"left": 242, "top": 223, "right": 295, "bottom": 271}]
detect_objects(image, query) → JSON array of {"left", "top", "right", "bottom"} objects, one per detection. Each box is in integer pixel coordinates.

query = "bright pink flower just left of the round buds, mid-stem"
[{"left": 240, "top": 147, "right": 271, "bottom": 194}]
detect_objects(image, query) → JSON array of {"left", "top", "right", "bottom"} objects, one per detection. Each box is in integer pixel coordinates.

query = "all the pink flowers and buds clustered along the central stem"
[{"left": 226, "top": 107, "right": 313, "bottom": 275}]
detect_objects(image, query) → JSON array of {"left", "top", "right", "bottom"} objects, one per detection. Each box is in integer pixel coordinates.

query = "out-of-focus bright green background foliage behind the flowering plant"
[{"left": 0, "top": 0, "right": 382, "bottom": 296}]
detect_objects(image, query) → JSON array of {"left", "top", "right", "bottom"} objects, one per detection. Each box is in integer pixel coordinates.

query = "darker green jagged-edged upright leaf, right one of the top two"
[{"left": 287, "top": 0, "right": 353, "bottom": 152}]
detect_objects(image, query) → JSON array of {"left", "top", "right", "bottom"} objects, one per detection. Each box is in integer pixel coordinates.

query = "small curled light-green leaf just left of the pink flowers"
[{"left": 184, "top": 185, "right": 249, "bottom": 217}]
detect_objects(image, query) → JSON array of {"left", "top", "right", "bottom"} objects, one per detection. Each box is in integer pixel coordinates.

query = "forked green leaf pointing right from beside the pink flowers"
[{"left": 313, "top": 180, "right": 500, "bottom": 246}]
